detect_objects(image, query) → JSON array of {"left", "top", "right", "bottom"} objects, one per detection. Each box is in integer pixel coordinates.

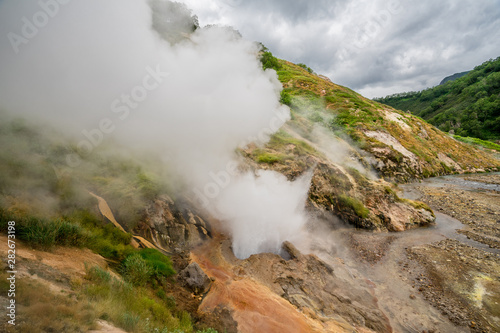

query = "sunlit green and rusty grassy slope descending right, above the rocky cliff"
[{"left": 272, "top": 60, "right": 500, "bottom": 180}]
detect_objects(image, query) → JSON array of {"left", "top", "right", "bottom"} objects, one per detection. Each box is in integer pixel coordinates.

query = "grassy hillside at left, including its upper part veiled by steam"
[{"left": 0, "top": 114, "right": 221, "bottom": 333}]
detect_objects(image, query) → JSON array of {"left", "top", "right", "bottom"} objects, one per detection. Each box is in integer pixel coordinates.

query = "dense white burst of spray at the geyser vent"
[{"left": 213, "top": 170, "right": 311, "bottom": 259}]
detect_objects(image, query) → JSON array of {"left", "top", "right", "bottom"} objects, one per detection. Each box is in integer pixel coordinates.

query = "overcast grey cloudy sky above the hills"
[{"left": 182, "top": 0, "right": 500, "bottom": 98}]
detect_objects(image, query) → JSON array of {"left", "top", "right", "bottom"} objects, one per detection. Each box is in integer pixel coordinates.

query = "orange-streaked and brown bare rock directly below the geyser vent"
[{"left": 193, "top": 239, "right": 392, "bottom": 332}]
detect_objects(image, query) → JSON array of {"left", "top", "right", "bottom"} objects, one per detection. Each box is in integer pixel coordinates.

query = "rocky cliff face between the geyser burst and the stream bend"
[{"left": 243, "top": 132, "right": 434, "bottom": 231}]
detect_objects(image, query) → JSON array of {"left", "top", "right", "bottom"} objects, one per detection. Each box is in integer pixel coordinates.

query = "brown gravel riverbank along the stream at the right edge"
[{"left": 403, "top": 174, "right": 500, "bottom": 332}]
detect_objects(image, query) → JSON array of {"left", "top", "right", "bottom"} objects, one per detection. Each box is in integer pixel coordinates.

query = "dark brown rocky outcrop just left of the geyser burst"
[{"left": 136, "top": 195, "right": 210, "bottom": 252}]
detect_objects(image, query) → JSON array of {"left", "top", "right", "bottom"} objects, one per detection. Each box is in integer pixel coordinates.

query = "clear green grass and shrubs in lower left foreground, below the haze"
[{"left": 0, "top": 208, "right": 207, "bottom": 333}]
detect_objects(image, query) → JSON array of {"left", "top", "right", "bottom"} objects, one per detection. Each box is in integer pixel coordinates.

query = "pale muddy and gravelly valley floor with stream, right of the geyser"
[{"left": 292, "top": 174, "right": 500, "bottom": 332}]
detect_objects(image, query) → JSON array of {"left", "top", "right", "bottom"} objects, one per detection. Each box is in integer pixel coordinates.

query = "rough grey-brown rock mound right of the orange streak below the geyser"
[{"left": 272, "top": 243, "right": 391, "bottom": 332}]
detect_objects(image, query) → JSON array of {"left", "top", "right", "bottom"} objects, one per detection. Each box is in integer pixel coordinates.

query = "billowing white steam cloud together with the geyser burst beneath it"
[{"left": 0, "top": 0, "right": 308, "bottom": 257}]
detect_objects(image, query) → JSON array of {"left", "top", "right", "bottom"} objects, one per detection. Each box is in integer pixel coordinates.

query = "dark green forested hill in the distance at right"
[{"left": 375, "top": 57, "right": 500, "bottom": 140}]
